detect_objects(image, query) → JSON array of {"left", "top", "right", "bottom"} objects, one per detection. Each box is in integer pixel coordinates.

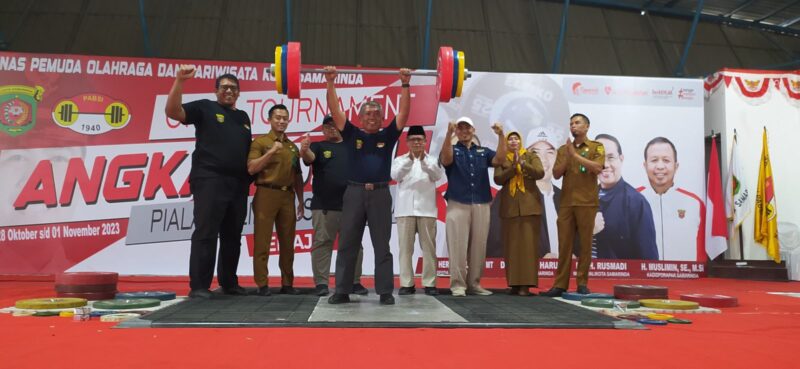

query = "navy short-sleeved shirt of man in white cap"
[{"left": 444, "top": 142, "right": 496, "bottom": 204}]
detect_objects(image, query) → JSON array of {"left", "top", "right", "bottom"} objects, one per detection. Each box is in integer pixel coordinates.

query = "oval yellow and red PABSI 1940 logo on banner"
[{"left": 53, "top": 93, "right": 131, "bottom": 135}]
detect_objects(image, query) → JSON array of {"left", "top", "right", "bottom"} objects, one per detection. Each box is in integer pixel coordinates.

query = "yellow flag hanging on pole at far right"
[{"left": 755, "top": 127, "right": 781, "bottom": 263}]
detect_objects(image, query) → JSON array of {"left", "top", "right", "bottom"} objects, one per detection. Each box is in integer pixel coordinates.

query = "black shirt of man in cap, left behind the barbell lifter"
[{"left": 309, "top": 141, "right": 349, "bottom": 211}]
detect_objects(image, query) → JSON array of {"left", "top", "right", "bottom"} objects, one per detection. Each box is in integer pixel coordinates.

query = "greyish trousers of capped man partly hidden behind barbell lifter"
[{"left": 311, "top": 209, "right": 364, "bottom": 286}]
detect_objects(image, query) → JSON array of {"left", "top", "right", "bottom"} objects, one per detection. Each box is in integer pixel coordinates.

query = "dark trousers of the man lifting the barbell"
[{"left": 336, "top": 185, "right": 394, "bottom": 295}]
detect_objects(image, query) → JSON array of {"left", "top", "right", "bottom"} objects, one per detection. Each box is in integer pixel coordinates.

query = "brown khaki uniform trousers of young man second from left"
[{"left": 253, "top": 187, "right": 297, "bottom": 287}]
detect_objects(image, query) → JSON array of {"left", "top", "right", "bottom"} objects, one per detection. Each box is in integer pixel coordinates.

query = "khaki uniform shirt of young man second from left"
[{"left": 247, "top": 131, "right": 301, "bottom": 186}]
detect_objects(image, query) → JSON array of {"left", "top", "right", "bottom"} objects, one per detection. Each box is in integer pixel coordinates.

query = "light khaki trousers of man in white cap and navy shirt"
[{"left": 445, "top": 200, "right": 491, "bottom": 291}]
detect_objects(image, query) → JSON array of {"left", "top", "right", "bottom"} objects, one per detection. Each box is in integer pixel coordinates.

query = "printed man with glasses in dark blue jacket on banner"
[{"left": 594, "top": 134, "right": 658, "bottom": 260}]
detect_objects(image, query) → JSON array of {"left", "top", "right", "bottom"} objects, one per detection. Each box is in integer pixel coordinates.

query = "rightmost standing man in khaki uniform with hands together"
[{"left": 542, "top": 113, "right": 605, "bottom": 297}]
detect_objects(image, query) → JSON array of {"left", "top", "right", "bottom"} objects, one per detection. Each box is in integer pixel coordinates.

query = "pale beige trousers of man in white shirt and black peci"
[{"left": 397, "top": 217, "right": 437, "bottom": 287}]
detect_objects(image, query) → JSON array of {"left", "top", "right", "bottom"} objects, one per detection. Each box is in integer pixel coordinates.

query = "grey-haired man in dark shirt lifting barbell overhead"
[{"left": 325, "top": 66, "right": 411, "bottom": 305}]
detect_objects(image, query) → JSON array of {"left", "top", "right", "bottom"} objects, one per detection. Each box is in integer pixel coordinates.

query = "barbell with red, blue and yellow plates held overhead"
[{"left": 270, "top": 42, "right": 472, "bottom": 102}]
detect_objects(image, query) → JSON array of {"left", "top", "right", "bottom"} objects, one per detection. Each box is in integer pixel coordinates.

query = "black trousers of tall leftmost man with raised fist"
[{"left": 189, "top": 176, "right": 250, "bottom": 290}]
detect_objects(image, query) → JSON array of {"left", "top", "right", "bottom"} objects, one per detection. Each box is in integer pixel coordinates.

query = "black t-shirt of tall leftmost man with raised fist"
[{"left": 182, "top": 99, "right": 252, "bottom": 179}]
